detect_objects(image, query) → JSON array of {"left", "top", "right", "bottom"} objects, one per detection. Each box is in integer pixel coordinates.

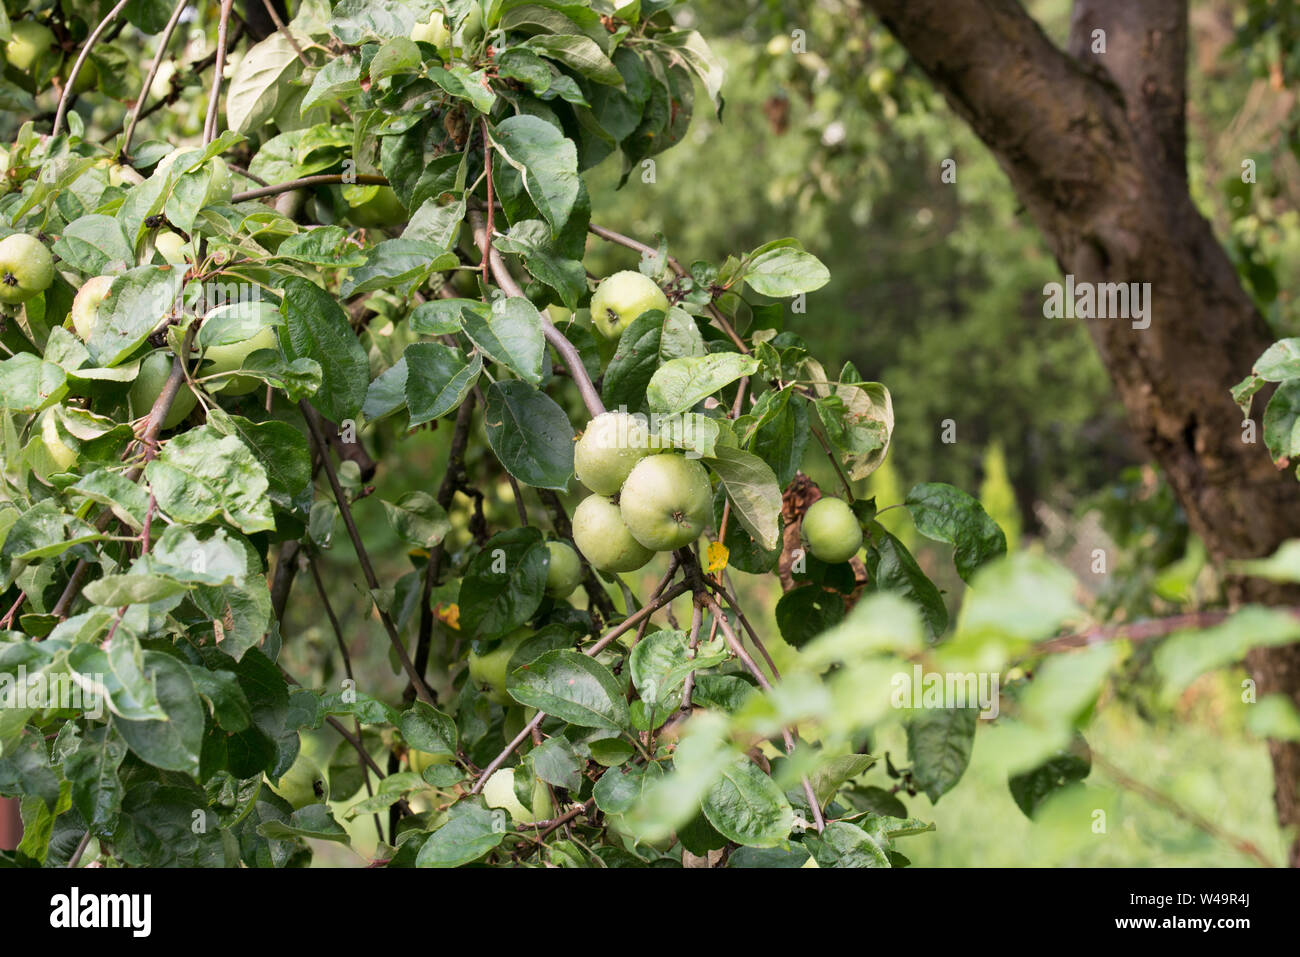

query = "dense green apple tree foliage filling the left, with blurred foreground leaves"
[{"left": 0, "top": 0, "right": 1297, "bottom": 867}]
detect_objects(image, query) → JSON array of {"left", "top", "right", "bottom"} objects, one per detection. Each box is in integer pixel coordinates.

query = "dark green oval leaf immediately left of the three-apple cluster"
[{"left": 484, "top": 380, "right": 573, "bottom": 492}]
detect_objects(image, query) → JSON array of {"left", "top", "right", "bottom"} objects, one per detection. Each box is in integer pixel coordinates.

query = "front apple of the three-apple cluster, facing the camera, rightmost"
[{"left": 619, "top": 452, "right": 714, "bottom": 551}]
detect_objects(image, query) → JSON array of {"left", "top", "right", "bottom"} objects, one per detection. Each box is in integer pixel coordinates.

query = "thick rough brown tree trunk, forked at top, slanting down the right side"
[{"left": 862, "top": 0, "right": 1300, "bottom": 866}]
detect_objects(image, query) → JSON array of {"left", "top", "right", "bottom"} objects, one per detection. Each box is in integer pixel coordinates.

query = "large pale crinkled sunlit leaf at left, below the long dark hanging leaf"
[{"left": 144, "top": 425, "right": 276, "bottom": 533}]
